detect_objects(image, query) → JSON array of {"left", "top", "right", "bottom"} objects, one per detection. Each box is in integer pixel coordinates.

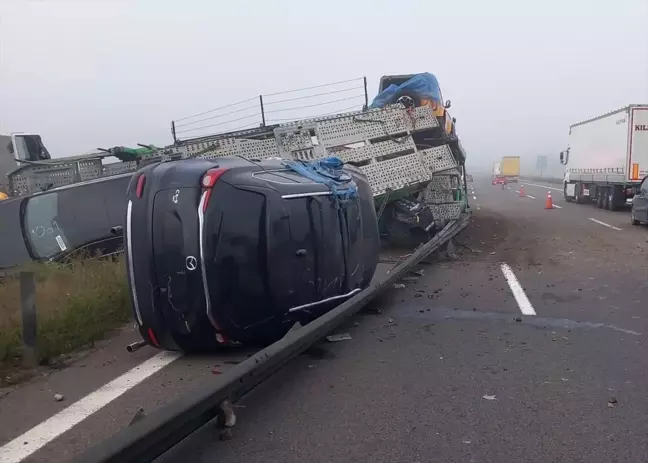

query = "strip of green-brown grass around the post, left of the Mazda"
[{"left": 0, "top": 258, "right": 131, "bottom": 382}]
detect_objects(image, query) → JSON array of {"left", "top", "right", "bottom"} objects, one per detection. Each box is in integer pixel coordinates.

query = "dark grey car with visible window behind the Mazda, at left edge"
[{"left": 0, "top": 174, "right": 130, "bottom": 270}]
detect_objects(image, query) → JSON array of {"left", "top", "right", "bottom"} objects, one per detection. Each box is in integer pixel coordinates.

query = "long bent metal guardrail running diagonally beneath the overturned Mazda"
[{"left": 75, "top": 213, "right": 471, "bottom": 463}]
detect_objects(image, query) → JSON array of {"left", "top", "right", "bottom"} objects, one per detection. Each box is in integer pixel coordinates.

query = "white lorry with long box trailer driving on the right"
[{"left": 560, "top": 105, "right": 648, "bottom": 210}]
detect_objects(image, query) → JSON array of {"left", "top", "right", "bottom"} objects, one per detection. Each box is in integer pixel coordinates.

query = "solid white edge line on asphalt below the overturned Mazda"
[{"left": 0, "top": 352, "right": 180, "bottom": 463}]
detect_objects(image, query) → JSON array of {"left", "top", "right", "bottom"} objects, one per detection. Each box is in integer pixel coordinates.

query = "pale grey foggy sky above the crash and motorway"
[{"left": 0, "top": 0, "right": 648, "bottom": 172}]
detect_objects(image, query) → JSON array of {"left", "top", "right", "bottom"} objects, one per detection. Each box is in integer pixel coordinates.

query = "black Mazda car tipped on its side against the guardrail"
[{"left": 124, "top": 158, "right": 380, "bottom": 352}]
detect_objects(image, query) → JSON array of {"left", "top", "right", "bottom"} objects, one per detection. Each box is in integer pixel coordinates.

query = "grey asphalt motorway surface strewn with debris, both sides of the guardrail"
[{"left": 0, "top": 175, "right": 648, "bottom": 463}]
